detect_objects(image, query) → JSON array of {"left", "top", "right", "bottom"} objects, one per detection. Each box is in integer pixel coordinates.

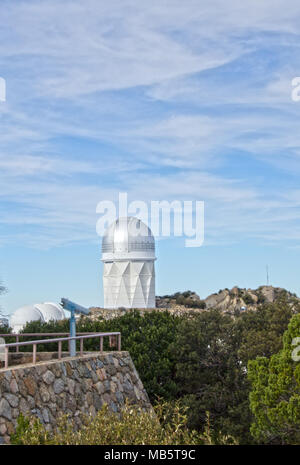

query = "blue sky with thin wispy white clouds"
[{"left": 0, "top": 0, "right": 300, "bottom": 313}]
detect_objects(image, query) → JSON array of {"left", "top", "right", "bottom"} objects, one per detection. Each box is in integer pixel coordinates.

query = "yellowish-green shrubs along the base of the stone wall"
[{"left": 11, "top": 403, "right": 230, "bottom": 445}]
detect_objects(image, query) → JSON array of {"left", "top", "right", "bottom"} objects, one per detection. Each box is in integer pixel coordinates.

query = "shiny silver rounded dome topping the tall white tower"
[{"left": 102, "top": 216, "right": 155, "bottom": 260}]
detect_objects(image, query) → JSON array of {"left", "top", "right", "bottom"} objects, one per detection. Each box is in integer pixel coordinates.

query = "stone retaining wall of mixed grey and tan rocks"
[{"left": 0, "top": 351, "right": 151, "bottom": 444}]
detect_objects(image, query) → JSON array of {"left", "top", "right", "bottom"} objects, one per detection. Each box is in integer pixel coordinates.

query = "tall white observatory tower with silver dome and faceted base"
[{"left": 102, "top": 217, "right": 156, "bottom": 308}]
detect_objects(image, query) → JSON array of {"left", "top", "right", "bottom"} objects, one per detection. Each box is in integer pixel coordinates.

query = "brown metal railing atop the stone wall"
[{"left": 0, "top": 332, "right": 121, "bottom": 368}]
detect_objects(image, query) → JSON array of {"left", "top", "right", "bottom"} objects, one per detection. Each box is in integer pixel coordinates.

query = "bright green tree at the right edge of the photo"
[{"left": 248, "top": 314, "right": 300, "bottom": 444}]
